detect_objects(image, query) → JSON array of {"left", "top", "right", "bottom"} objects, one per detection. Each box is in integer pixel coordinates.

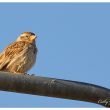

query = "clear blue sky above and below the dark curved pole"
[{"left": 0, "top": 3, "right": 110, "bottom": 107}]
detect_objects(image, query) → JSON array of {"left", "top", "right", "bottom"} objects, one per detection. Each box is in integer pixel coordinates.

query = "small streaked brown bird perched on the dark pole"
[{"left": 0, "top": 32, "right": 38, "bottom": 75}]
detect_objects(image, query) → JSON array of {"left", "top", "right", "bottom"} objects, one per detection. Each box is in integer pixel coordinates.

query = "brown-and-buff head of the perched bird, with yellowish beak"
[{"left": 17, "top": 32, "right": 36, "bottom": 43}]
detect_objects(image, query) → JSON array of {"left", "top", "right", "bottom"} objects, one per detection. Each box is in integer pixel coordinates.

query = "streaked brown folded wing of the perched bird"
[{"left": 0, "top": 41, "right": 28, "bottom": 69}]
